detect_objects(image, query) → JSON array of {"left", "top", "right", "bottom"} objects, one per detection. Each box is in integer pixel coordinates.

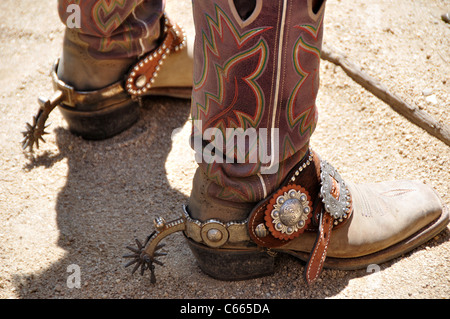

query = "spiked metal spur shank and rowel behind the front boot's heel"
[{"left": 123, "top": 217, "right": 186, "bottom": 284}]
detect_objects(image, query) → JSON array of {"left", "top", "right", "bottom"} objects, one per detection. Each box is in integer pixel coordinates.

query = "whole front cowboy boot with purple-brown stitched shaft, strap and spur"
[{"left": 124, "top": 0, "right": 449, "bottom": 284}]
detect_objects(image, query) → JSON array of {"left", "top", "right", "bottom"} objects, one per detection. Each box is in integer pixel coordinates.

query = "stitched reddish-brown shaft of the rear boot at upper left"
[{"left": 58, "top": 0, "right": 165, "bottom": 60}]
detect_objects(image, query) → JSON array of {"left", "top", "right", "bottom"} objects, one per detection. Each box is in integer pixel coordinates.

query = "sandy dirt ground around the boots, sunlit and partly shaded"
[{"left": 0, "top": 0, "right": 450, "bottom": 299}]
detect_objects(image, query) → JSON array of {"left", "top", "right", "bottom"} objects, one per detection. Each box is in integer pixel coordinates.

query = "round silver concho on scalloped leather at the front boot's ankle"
[{"left": 270, "top": 189, "right": 311, "bottom": 235}]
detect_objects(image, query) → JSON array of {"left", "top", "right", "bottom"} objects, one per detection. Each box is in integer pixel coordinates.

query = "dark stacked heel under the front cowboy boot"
[{"left": 186, "top": 238, "right": 275, "bottom": 281}]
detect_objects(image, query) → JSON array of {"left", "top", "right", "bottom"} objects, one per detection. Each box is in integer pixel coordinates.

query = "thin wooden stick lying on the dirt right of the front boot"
[{"left": 321, "top": 44, "right": 450, "bottom": 146}]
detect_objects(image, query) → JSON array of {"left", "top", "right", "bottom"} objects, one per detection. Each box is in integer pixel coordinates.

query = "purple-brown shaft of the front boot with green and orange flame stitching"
[{"left": 192, "top": 0, "right": 325, "bottom": 202}]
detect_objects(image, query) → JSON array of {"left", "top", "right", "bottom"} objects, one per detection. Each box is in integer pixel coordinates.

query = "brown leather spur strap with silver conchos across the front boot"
[{"left": 248, "top": 151, "right": 352, "bottom": 284}]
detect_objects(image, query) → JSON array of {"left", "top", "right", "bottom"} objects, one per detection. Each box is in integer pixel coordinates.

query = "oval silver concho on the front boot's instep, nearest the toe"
[{"left": 320, "top": 160, "right": 351, "bottom": 224}]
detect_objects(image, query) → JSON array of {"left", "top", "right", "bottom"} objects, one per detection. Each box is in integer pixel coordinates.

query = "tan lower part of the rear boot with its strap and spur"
[{"left": 23, "top": 4, "right": 193, "bottom": 150}]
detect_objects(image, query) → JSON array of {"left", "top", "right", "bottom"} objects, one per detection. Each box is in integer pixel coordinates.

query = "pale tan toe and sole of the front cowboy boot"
[{"left": 282, "top": 180, "right": 449, "bottom": 270}]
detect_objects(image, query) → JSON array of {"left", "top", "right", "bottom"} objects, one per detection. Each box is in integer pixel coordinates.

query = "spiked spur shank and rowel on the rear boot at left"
[{"left": 21, "top": 91, "right": 64, "bottom": 153}]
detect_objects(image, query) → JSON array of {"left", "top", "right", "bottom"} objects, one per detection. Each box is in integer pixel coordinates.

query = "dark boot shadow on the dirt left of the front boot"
[{"left": 14, "top": 97, "right": 190, "bottom": 299}]
